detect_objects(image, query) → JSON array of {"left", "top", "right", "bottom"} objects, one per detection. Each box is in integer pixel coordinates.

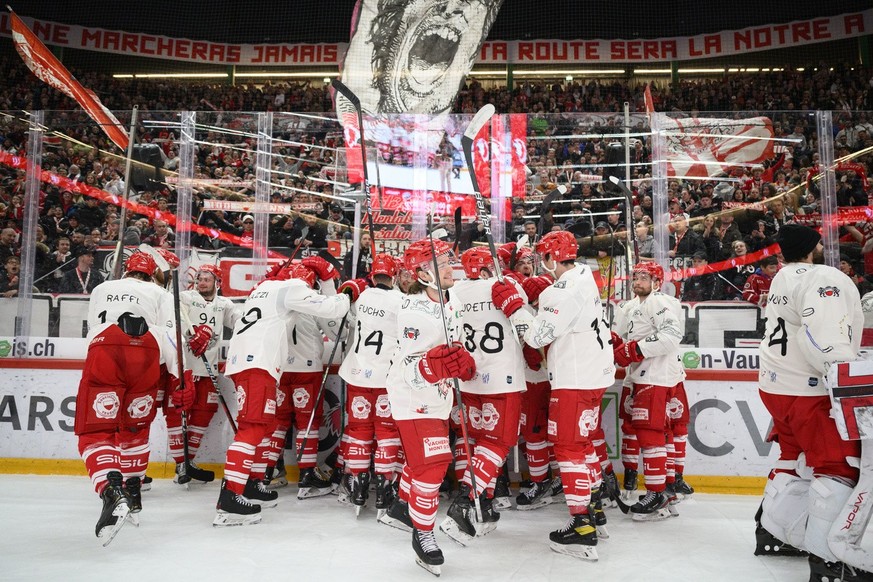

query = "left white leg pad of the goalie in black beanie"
[{"left": 761, "top": 473, "right": 810, "bottom": 547}]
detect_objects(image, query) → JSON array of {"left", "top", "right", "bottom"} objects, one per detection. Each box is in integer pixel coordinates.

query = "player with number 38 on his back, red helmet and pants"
[{"left": 440, "top": 247, "right": 525, "bottom": 545}]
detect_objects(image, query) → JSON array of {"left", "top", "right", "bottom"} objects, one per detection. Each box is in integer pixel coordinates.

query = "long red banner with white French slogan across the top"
[{"left": 0, "top": 8, "right": 873, "bottom": 65}]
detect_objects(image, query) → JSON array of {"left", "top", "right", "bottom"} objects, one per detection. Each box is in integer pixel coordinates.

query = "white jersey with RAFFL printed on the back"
[{"left": 87, "top": 277, "right": 178, "bottom": 376}]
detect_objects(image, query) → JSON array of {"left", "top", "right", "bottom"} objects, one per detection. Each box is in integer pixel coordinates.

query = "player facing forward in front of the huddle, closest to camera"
[{"left": 385, "top": 240, "right": 476, "bottom": 575}]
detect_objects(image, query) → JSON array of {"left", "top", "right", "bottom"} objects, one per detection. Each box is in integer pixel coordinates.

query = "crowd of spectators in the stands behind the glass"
[{"left": 0, "top": 52, "right": 873, "bottom": 304}]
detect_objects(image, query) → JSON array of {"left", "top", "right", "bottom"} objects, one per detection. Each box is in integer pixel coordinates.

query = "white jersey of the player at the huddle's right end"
[{"left": 615, "top": 291, "right": 685, "bottom": 386}]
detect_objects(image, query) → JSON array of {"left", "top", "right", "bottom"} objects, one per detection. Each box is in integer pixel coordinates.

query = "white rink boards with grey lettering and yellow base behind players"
[{"left": 0, "top": 362, "right": 778, "bottom": 494}]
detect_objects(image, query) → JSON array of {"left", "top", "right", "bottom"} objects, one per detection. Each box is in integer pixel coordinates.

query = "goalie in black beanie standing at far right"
[{"left": 759, "top": 224, "right": 873, "bottom": 581}]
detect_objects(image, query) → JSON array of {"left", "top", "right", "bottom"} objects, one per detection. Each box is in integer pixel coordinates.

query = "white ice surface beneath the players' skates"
[{"left": 0, "top": 475, "right": 809, "bottom": 582}]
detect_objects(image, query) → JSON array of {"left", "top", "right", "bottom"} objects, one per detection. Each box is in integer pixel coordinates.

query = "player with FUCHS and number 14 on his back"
[{"left": 339, "top": 253, "right": 403, "bottom": 517}]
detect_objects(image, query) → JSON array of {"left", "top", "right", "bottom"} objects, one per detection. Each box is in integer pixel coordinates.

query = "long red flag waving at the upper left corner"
[{"left": 9, "top": 11, "right": 127, "bottom": 150}]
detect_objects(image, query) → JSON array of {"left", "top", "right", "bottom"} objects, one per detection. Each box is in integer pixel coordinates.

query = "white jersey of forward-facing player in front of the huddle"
[{"left": 385, "top": 291, "right": 459, "bottom": 420}]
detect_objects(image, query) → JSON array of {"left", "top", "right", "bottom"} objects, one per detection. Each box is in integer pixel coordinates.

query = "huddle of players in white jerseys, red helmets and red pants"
[{"left": 75, "top": 225, "right": 872, "bottom": 575}]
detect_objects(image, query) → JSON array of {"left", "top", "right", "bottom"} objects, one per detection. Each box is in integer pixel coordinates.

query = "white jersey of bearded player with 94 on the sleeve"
[{"left": 179, "top": 289, "right": 242, "bottom": 377}]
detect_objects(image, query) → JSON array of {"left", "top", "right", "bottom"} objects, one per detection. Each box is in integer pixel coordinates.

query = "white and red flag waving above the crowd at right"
[{"left": 645, "top": 85, "right": 774, "bottom": 178}]
